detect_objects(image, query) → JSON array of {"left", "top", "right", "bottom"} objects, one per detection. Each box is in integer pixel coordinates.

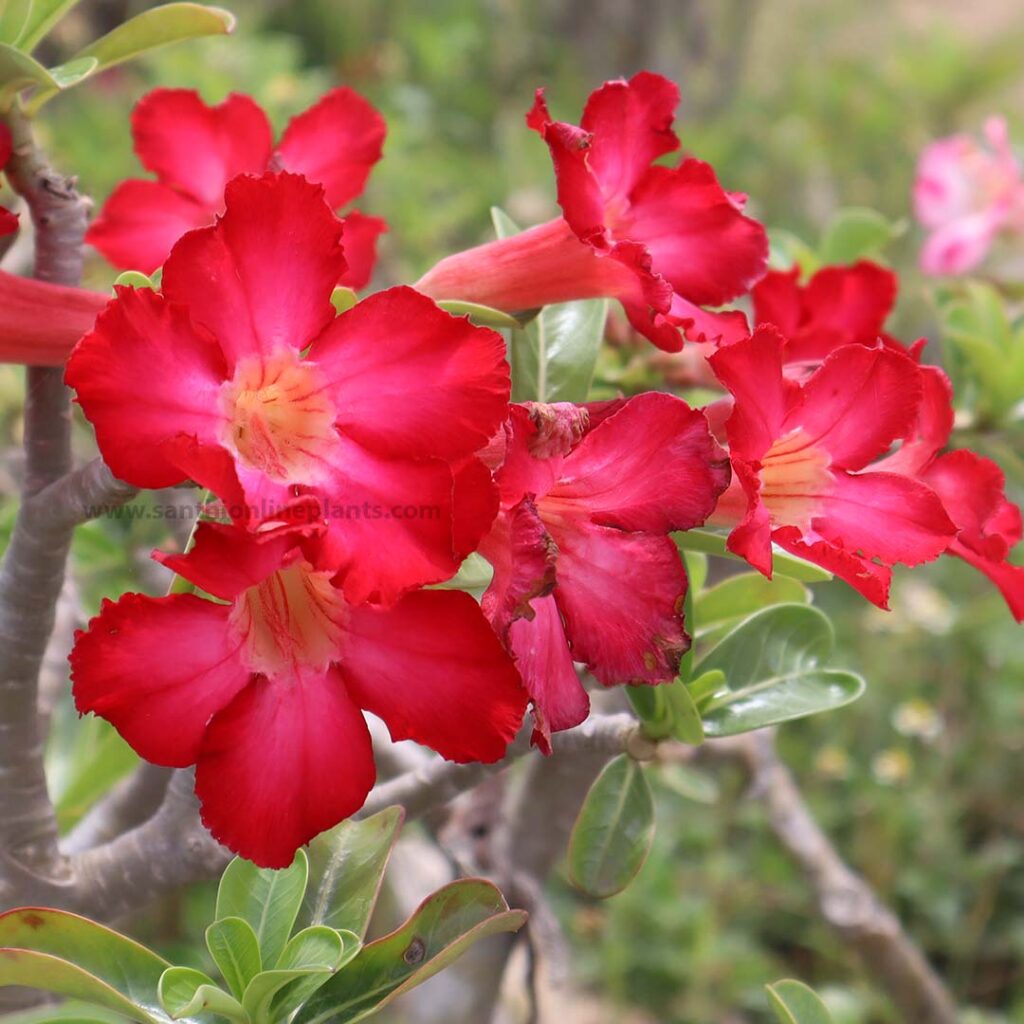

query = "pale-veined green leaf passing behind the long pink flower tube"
[{"left": 490, "top": 207, "right": 608, "bottom": 401}]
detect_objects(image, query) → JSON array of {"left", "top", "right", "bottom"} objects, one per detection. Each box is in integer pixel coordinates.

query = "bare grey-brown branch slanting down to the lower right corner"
[{"left": 701, "top": 732, "right": 957, "bottom": 1024}]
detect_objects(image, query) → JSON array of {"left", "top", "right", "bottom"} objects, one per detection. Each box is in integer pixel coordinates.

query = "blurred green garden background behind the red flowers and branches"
[{"left": 0, "top": 0, "right": 1024, "bottom": 1024}]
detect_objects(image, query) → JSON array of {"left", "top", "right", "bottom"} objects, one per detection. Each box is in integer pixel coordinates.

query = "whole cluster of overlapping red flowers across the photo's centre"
[{"left": 59, "top": 74, "right": 1024, "bottom": 866}]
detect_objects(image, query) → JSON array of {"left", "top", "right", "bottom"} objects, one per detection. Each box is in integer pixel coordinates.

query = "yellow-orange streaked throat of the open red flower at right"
[{"left": 761, "top": 427, "right": 831, "bottom": 532}]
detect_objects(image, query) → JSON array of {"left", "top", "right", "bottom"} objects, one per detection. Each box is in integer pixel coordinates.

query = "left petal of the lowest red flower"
[{"left": 71, "top": 594, "right": 249, "bottom": 768}]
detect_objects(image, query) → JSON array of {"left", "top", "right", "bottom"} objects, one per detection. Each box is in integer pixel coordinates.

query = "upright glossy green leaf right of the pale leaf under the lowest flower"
[{"left": 299, "top": 807, "right": 403, "bottom": 939}]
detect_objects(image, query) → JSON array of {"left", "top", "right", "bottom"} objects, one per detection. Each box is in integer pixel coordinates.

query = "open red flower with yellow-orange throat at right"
[{"left": 711, "top": 327, "right": 955, "bottom": 607}]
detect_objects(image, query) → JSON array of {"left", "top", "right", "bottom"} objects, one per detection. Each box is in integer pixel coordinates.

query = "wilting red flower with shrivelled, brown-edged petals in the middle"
[{"left": 480, "top": 393, "right": 729, "bottom": 750}]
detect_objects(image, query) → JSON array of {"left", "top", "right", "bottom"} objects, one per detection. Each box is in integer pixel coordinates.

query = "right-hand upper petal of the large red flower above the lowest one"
[{"left": 309, "top": 288, "right": 511, "bottom": 459}]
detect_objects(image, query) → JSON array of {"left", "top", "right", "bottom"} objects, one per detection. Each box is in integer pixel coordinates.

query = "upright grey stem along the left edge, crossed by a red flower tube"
[{"left": 0, "top": 112, "right": 89, "bottom": 872}]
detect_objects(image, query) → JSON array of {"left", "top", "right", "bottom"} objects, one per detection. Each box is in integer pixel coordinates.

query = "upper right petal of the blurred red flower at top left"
[{"left": 275, "top": 87, "right": 387, "bottom": 210}]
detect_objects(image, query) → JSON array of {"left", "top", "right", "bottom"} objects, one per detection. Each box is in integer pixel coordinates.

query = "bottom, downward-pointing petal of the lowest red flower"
[{"left": 196, "top": 670, "right": 376, "bottom": 867}]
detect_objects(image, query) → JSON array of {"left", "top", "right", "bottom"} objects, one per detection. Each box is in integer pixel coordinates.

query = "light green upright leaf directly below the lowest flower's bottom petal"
[{"left": 217, "top": 850, "right": 309, "bottom": 969}]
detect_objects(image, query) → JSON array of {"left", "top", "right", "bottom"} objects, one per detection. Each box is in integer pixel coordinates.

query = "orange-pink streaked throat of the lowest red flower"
[{"left": 231, "top": 561, "right": 345, "bottom": 676}]
